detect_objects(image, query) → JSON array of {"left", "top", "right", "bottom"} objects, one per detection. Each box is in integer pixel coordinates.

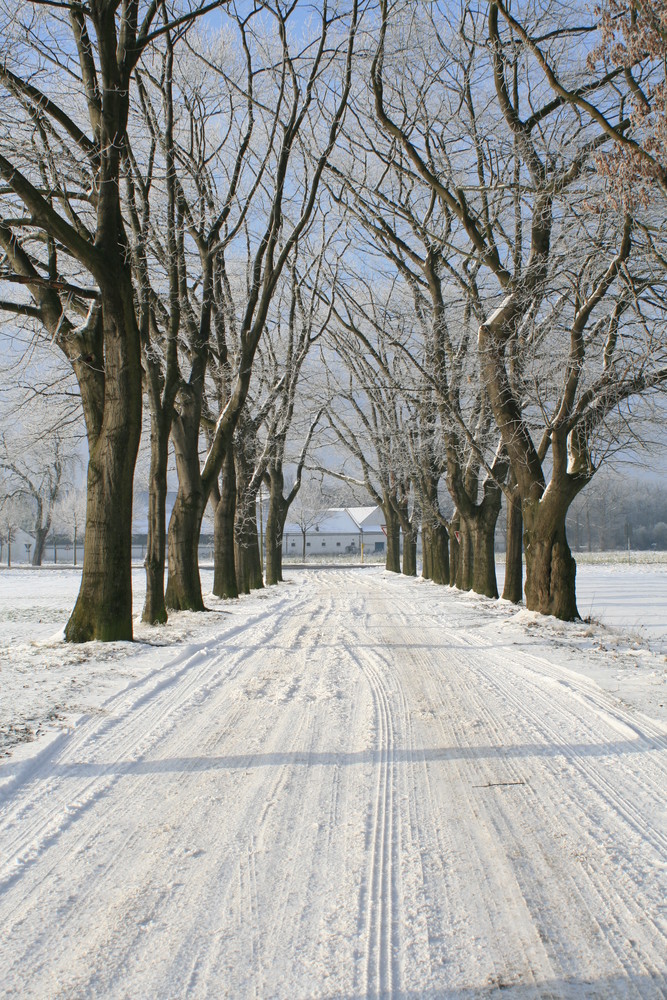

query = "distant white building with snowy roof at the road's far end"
[{"left": 283, "top": 507, "right": 387, "bottom": 556}]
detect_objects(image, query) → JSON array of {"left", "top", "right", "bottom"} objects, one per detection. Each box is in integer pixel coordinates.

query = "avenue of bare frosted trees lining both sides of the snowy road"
[{"left": 0, "top": 0, "right": 667, "bottom": 641}]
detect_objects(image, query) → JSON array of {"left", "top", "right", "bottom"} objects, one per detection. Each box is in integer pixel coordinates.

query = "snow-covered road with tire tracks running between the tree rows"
[{"left": 0, "top": 570, "right": 667, "bottom": 1000}]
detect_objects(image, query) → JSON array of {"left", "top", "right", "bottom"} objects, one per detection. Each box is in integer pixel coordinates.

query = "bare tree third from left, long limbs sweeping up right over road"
[{"left": 153, "top": 0, "right": 358, "bottom": 610}]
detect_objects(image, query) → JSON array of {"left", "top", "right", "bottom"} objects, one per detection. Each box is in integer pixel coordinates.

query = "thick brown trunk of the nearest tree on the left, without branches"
[{"left": 65, "top": 282, "right": 142, "bottom": 642}]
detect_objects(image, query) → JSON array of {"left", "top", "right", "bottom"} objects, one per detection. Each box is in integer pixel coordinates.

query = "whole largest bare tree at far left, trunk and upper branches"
[{"left": 0, "top": 0, "right": 230, "bottom": 641}]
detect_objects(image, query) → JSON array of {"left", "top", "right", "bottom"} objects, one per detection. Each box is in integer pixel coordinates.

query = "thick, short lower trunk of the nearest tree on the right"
[{"left": 523, "top": 496, "right": 579, "bottom": 621}]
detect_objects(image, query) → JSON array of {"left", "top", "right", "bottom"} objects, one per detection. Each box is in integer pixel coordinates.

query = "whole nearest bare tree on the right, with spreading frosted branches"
[{"left": 372, "top": 3, "right": 667, "bottom": 618}]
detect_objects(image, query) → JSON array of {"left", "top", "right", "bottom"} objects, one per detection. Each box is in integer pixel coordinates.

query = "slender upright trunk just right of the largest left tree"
[{"left": 141, "top": 413, "right": 169, "bottom": 625}]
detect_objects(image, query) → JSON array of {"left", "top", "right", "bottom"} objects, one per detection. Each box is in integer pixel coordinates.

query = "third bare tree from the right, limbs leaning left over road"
[{"left": 334, "top": 74, "right": 509, "bottom": 597}]
